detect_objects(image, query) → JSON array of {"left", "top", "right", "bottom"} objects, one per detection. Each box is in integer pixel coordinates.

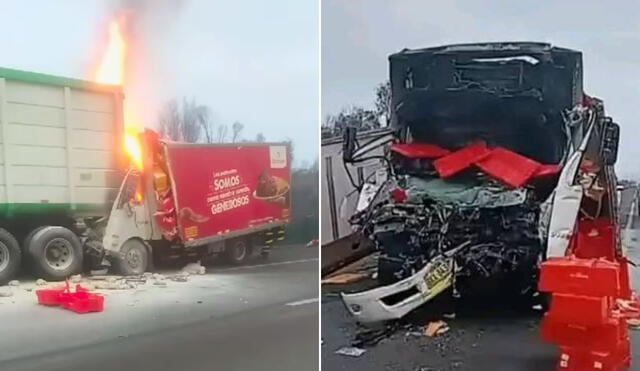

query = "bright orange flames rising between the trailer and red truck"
[{"left": 95, "top": 17, "right": 142, "bottom": 169}]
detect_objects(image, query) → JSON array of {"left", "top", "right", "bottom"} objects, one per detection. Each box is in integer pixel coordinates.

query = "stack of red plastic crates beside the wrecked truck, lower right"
[{"left": 539, "top": 257, "right": 631, "bottom": 371}]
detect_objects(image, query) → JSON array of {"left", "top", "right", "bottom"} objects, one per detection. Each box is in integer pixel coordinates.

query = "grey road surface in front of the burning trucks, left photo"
[{"left": 0, "top": 247, "right": 319, "bottom": 371}]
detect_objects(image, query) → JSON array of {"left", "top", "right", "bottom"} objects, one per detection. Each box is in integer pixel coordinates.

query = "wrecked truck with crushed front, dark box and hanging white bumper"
[{"left": 342, "top": 42, "right": 618, "bottom": 322}]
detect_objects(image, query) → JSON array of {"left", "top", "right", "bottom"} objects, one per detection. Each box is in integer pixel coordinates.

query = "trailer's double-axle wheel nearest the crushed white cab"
[{"left": 24, "top": 226, "right": 82, "bottom": 281}]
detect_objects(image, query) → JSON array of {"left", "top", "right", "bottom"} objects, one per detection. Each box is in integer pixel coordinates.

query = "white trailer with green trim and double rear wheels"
[{"left": 0, "top": 68, "right": 126, "bottom": 285}]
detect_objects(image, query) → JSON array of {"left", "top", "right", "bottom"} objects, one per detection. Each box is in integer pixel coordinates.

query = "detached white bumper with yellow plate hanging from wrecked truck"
[{"left": 341, "top": 258, "right": 454, "bottom": 323}]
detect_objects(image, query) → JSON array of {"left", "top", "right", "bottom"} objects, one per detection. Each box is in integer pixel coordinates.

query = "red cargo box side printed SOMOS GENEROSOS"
[{"left": 167, "top": 144, "right": 291, "bottom": 241}]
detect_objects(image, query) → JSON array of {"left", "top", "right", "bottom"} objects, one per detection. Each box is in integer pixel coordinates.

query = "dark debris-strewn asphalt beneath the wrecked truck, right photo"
[{"left": 321, "top": 231, "right": 640, "bottom": 371}]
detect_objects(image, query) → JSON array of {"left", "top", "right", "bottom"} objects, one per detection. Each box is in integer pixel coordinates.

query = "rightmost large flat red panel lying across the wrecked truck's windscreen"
[{"left": 475, "top": 147, "right": 540, "bottom": 188}]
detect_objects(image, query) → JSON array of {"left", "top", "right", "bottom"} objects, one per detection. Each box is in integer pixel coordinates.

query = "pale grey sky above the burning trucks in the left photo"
[{"left": 0, "top": 0, "right": 319, "bottom": 165}]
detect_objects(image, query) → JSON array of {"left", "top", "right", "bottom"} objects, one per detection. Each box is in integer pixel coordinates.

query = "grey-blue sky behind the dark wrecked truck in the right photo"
[{"left": 321, "top": 0, "right": 640, "bottom": 180}]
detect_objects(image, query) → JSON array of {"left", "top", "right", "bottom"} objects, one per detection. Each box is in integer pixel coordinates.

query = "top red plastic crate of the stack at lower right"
[{"left": 538, "top": 257, "right": 620, "bottom": 296}]
